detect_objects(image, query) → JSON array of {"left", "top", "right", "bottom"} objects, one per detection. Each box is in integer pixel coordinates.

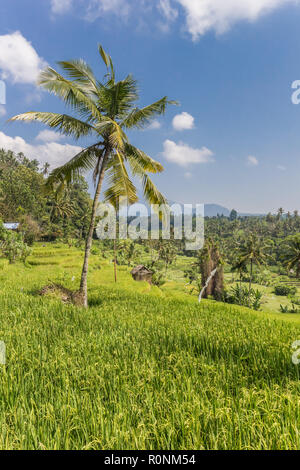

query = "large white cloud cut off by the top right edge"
[{"left": 175, "top": 0, "right": 299, "bottom": 40}]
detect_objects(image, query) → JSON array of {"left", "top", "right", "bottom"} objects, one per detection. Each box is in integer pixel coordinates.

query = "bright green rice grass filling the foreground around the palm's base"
[{"left": 0, "top": 246, "right": 300, "bottom": 449}]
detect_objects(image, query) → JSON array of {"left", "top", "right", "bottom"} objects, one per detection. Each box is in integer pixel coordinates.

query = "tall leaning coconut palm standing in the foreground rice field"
[{"left": 12, "top": 46, "right": 175, "bottom": 307}]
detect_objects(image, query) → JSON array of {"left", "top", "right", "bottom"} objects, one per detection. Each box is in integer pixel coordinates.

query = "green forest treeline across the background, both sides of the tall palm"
[{"left": 0, "top": 150, "right": 300, "bottom": 306}]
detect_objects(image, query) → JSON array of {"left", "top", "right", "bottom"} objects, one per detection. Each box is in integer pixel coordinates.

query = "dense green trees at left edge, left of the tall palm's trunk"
[{"left": 0, "top": 149, "right": 91, "bottom": 244}]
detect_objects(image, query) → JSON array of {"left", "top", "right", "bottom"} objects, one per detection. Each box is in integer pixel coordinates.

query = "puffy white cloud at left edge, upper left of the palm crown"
[{"left": 0, "top": 31, "right": 47, "bottom": 84}]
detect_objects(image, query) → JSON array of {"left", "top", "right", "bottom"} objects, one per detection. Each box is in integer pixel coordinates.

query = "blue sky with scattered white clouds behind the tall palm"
[{"left": 0, "top": 0, "right": 300, "bottom": 212}]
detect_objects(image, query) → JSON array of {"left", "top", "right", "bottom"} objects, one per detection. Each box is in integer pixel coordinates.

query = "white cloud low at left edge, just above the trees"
[{"left": 0, "top": 132, "right": 81, "bottom": 168}]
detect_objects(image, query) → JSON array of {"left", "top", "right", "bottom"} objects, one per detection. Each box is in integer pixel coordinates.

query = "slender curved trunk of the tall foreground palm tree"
[{"left": 79, "top": 148, "right": 109, "bottom": 308}]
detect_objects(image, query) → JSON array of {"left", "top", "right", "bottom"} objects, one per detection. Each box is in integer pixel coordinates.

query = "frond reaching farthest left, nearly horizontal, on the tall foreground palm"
[{"left": 9, "top": 111, "right": 98, "bottom": 139}]
